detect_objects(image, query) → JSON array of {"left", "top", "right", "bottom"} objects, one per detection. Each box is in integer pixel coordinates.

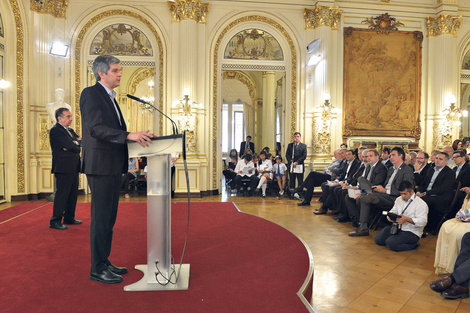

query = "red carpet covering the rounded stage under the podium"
[{"left": 0, "top": 203, "right": 312, "bottom": 313}]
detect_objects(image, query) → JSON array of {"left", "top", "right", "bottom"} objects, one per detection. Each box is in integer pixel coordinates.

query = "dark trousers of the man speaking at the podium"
[{"left": 87, "top": 174, "right": 121, "bottom": 273}]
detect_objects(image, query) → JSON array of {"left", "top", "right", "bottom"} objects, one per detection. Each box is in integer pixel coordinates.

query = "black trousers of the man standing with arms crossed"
[{"left": 50, "top": 172, "right": 78, "bottom": 224}]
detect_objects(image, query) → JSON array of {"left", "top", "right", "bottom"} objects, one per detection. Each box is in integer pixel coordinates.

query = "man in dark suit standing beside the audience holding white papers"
[{"left": 286, "top": 132, "right": 307, "bottom": 189}]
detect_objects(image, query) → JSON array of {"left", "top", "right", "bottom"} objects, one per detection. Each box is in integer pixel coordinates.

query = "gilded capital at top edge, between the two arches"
[{"left": 168, "top": 0, "right": 209, "bottom": 24}]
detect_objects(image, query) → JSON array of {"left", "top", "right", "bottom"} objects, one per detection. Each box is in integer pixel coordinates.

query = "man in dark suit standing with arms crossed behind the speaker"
[{"left": 49, "top": 108, "right": 82, "bottom": 230}]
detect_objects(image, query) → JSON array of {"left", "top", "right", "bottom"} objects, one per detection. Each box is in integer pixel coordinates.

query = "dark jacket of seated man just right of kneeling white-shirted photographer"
[{"left": 418, "top": 166, "right": 455, "bottom": 201}]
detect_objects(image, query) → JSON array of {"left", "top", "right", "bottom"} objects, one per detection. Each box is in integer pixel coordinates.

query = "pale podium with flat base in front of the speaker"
[{"left": 124, "top": 134, "right": 189, "bottom": 291}]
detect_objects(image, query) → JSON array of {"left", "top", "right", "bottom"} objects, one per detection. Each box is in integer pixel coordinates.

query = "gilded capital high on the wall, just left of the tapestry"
[{"left": 304, "top": 4, "right": 343, "bottom": 30}]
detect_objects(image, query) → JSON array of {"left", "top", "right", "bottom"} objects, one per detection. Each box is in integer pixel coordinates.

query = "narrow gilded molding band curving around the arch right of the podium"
[{"left": 212, "top": 15, "right": 297, "bottom": 189}]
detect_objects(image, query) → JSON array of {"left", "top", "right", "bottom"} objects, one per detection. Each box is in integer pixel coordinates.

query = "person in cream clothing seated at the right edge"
[{"left": 434, "top": 196, "right": 470, "bottom": 275}]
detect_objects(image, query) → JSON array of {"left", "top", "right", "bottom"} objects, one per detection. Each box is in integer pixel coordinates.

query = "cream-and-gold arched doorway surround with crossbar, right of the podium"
[{"left": 211, "top": 13, "right": 299, "bottom": 190}]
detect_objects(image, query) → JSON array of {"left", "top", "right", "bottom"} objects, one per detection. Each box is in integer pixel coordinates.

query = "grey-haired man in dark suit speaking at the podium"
[{"left": 80, "top": 55, "right": 153, "bottom": 283}]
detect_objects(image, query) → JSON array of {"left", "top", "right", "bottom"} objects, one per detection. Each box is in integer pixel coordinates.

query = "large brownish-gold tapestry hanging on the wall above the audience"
[{"left": 343, "top": 27, "right": 423, "bottom": 140}]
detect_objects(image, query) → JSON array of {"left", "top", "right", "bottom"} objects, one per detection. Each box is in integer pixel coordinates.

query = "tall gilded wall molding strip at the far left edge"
[{"left": 10, "top": 0, "right": 25, "bottom": 193}]
